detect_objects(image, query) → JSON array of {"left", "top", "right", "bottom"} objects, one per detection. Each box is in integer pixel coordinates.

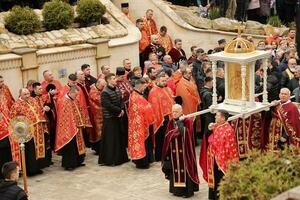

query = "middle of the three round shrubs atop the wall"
[{"left": 43, "top": 0, "right": 74, "bottom": 30}]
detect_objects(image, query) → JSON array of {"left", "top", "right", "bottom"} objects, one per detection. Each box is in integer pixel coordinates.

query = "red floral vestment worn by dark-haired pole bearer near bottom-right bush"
[{"left": 203, "top": 122, "right": 239, "bottom": 188}]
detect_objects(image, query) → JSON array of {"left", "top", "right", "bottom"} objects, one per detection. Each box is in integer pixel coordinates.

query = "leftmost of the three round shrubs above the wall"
[{"left": 4, "top": 6, "right": 42, "bottom": 35}]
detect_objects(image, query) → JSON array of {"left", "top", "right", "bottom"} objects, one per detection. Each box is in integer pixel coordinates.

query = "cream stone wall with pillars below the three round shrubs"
[{"left": 0, "top": 0, "right": 141, "bottom": 98}]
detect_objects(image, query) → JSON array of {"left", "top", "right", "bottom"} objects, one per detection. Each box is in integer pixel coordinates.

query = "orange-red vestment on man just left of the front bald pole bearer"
[{"left": 148, "top": 86, "right": 174, "bottom": 133}]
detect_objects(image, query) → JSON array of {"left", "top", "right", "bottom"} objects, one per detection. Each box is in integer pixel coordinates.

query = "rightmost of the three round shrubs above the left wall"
[{"left": 76, "top": 0, "right": 106, "bottom": 26}]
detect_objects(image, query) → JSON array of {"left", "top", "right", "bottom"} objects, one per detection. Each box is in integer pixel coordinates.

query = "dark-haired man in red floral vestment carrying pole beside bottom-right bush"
[{"left": 200, "top": 110, "right": 239, "bottom": 199}]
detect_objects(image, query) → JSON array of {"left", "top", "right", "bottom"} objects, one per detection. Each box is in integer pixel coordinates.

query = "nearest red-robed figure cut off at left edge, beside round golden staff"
[{"left": 0, "top": 102, "right": 20, "bottom": 179}]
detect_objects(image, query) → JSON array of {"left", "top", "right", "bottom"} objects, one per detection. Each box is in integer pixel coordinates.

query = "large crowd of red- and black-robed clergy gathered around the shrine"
[{"left": 0, "top": 5, "right": 300, "bottom": 199}]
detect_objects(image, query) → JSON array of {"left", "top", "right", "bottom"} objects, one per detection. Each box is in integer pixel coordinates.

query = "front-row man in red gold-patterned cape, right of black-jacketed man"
[{"left": 128, "top": 78, "right": 155, "bottom": 169}]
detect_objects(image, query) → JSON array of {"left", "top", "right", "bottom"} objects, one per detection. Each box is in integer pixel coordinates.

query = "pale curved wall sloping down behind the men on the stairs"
[{"left": 113, "top": 0, "right": 264, "bottom": 54}]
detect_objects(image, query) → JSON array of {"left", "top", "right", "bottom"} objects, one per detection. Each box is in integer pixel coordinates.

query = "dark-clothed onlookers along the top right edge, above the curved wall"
[{"left": 167, "top": 0, "right": 297, "bottom": 25}]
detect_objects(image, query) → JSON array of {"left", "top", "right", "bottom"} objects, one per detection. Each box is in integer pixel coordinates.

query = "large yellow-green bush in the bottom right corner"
[{"left": 219, "top": 148, "right": 300, "bottom": 200}]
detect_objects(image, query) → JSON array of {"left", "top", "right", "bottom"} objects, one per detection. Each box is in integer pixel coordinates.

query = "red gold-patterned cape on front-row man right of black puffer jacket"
[{"left": 128, "top": 91, "right": 154, "bottom": 160}]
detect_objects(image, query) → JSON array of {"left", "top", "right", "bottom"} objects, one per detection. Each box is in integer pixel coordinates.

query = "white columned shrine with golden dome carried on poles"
[{"left": 209, "top": 36, "right": 271, "bottom": 117}]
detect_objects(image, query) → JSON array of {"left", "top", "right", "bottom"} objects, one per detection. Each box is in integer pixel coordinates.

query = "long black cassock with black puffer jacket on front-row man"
[{"left": 98, "top": 86, "right": 128, "bottom": 166}]
